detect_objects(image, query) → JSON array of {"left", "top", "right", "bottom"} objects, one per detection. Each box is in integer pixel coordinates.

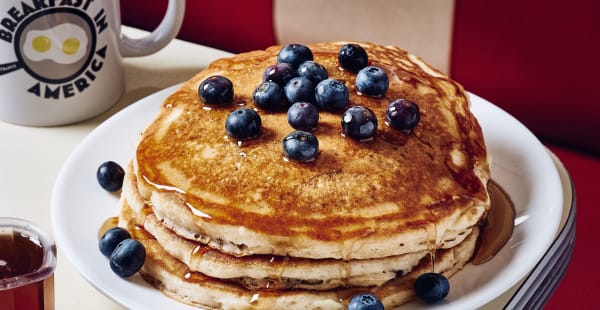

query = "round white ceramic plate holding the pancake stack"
[{"left": 52, "top": 86, "right": 563, "bottom": 309}]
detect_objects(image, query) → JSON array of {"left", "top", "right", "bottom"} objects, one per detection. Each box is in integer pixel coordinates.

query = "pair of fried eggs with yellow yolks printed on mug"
[{"left": 23, "top": 23, "right": 88, "bottom": 64}]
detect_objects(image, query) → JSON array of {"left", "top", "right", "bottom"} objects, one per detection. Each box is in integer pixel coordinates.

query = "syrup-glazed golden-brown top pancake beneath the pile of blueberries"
[{"left": 135, "top": 43, "right": 489, "bottom": 259}]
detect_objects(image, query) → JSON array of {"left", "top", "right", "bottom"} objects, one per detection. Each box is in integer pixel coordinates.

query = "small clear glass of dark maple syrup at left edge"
[{"left": 0, "top": 219, "right": 56, "bottom": 310}]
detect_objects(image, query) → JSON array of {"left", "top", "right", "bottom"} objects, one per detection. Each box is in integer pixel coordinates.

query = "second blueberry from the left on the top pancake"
[{"left": 225, "top": 108, "right": 262, "bottom": 140}]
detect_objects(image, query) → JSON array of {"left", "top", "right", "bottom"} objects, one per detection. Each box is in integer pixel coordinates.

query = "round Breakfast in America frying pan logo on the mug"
[{"left": 0, "top": 0, "right": 108, "bottom": 99}]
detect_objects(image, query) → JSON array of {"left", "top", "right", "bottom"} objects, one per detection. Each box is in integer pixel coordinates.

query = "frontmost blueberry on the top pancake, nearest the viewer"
[{"left": 282, "top": 130, "right": 319, "bottom": 162}]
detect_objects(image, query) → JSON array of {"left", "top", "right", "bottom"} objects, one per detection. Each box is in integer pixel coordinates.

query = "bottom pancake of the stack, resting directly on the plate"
[{"left": 119, "top": 190, "right": 479, "bottom": 310}]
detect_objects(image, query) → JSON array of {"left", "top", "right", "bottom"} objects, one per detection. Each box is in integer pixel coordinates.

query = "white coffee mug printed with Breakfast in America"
[{"left": 0, "top": 0, "right": 185, "bottom": 126}]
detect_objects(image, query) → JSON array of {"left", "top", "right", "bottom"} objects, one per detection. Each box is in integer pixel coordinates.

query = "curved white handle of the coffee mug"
[{"left": 119, "top": 0, "right": 185, "bottom": 57}]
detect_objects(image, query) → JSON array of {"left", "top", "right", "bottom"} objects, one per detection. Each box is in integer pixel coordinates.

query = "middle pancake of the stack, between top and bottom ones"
[{"left": 121, "top": 165, "right": 436, "bottom": 291}]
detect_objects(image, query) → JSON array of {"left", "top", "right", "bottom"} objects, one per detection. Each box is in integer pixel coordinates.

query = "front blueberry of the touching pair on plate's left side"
[{"left": 109, "top": 239, "right": 146, "bottom": 278}]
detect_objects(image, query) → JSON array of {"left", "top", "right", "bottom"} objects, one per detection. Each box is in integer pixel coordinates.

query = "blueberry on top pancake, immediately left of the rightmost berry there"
[{"left": 342, "top": 106, "right": 377, "bottom": 141}]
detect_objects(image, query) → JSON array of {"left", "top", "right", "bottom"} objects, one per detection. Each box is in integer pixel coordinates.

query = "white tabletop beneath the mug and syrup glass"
[{"left": 0, "top": 28, "right": 229, "bottom": 310}]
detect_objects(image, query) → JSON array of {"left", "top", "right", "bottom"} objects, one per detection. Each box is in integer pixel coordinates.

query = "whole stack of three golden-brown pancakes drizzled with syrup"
[{"left": 120, "top": 43, "right": 489, "bottom": 309}]
